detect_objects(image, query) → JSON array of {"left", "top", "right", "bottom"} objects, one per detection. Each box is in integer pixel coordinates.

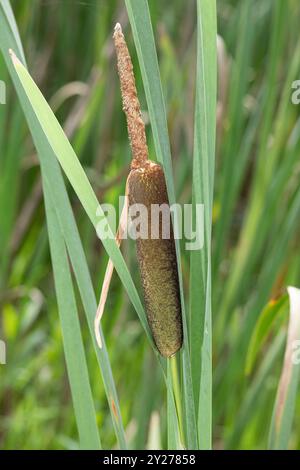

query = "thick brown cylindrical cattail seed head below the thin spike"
[{"left": 127, "top": 160, "right": 183, "bottom": 357}]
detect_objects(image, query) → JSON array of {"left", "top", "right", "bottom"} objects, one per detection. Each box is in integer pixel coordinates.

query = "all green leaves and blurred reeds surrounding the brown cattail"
[{"left": 0, "top": 0, "right": 300, "bottom": 449}]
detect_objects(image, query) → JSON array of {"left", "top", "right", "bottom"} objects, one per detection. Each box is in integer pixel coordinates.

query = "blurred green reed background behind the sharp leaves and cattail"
[{"left": 0, "top": 0, "right": 300, "bottom": 449}]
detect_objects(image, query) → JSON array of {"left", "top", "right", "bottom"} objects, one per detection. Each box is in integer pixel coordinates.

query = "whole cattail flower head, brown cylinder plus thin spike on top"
[{"left": 114, "top": 24, "right": 183, "bottom": 357}]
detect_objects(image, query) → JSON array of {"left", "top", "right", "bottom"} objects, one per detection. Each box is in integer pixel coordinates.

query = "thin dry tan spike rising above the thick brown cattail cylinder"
[{"left": 113, "top": 23, "right": 148, "bottom": 168}]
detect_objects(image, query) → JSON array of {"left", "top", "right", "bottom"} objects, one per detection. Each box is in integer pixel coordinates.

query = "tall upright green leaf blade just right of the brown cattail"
[{"left": 190, "top": 0, "right": 217, "bottom": 449}]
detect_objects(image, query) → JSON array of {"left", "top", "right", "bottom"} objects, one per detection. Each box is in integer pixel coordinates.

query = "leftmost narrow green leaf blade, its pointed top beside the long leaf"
[{"left": 44, "top": 185, "right": 100, "bottom": 449}]
